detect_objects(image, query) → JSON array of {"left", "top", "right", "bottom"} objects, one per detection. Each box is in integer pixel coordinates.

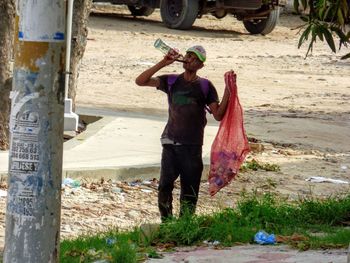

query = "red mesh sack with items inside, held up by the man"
[{"left": 209, "top": 71, "right": 249, "bottom": 196}]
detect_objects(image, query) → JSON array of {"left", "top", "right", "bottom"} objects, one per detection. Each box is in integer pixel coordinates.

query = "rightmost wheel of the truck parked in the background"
[{"left": 243, "top": 7, "right": 280, "bottom": 35}]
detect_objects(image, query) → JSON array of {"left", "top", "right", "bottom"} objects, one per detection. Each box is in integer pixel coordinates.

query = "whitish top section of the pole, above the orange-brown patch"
[{"left": 17, "top": 0, "right": 65, "bottom": 42}]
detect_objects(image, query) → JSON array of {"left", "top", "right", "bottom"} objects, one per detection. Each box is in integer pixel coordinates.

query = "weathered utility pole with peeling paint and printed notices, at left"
[{"left": 4, "top": 0, "right": 66, "bottom": 263}]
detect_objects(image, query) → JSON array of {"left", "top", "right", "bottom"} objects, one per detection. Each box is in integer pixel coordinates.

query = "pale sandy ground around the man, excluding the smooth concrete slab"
[{"left": 1, "top": 2, "right": 350, "bottom": 245}]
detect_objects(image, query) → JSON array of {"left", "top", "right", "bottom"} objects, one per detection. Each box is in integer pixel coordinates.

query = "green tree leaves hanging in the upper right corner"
[{"left": 294, "top": 0, "right": 350, "bottom": 59}]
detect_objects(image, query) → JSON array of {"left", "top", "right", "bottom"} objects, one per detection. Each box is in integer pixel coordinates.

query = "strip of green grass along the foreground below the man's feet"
[{"left": 61, "top": 192, "right": 350, "bottom": 263}]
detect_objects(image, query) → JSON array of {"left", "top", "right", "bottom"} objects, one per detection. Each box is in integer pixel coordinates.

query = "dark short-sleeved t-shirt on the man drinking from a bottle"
[{"left": 157, "top": 74, "right": 219, "bottom": 145}]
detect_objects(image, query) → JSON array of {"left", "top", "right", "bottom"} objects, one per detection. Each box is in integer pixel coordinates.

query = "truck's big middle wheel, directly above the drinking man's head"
[{"left": 160, "top": 0, "right": 199, "bottom": 29}]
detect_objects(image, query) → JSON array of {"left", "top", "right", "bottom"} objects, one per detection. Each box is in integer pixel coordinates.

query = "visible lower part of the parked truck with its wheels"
[{"left": 94, "top": 0, "right": 279, "bottom": 35}]
